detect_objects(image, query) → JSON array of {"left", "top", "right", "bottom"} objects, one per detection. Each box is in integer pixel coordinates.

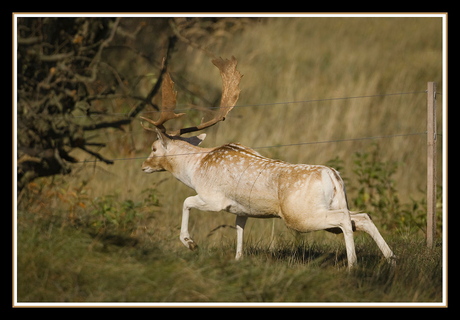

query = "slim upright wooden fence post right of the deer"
[{"left": 426, "top": 82, "right": 436, "bottom": 248}]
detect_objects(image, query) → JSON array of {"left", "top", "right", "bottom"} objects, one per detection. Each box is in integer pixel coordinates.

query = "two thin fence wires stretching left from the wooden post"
[{"left": 75, "top": 90, "right": 432, "bottom": 163}]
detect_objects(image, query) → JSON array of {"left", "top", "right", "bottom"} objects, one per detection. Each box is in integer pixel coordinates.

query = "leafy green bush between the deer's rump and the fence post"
[{"left": 327, "top": 143, "right": 442, "bottom": 233}]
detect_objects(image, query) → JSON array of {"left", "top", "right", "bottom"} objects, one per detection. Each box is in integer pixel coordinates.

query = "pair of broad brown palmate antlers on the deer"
[{"left": 141, "top": 56, "right": 242, "bottom": 136}]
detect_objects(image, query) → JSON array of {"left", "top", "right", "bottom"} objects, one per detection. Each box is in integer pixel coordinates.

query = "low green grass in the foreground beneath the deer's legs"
[{"left": 17, "top": 181, "right": 442, "bottom": 303}]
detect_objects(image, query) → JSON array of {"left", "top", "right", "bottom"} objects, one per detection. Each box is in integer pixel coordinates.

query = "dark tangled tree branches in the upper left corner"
[{"left": 17, "top": 17, "right": 175, "bottom": 189}]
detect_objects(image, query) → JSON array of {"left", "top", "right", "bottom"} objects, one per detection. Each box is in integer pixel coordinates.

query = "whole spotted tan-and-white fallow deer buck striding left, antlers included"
[{"left": 141, "top": 57, "right": 394, "bottom": 268}]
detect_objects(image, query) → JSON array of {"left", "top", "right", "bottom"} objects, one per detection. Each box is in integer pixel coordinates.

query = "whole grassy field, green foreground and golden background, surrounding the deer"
[{"left": 17, "top": 18, "right": 445, "bottom": 303}]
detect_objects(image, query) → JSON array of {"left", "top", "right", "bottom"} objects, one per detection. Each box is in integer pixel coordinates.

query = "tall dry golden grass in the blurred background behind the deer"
[{"left": 90, "top": 18, "right": 443, "bottom": 204}]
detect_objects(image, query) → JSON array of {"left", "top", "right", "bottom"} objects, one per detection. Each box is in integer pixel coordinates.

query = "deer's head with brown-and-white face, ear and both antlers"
[{"left": 141, "top": 56, "right": 242, "bottom": 173}]
